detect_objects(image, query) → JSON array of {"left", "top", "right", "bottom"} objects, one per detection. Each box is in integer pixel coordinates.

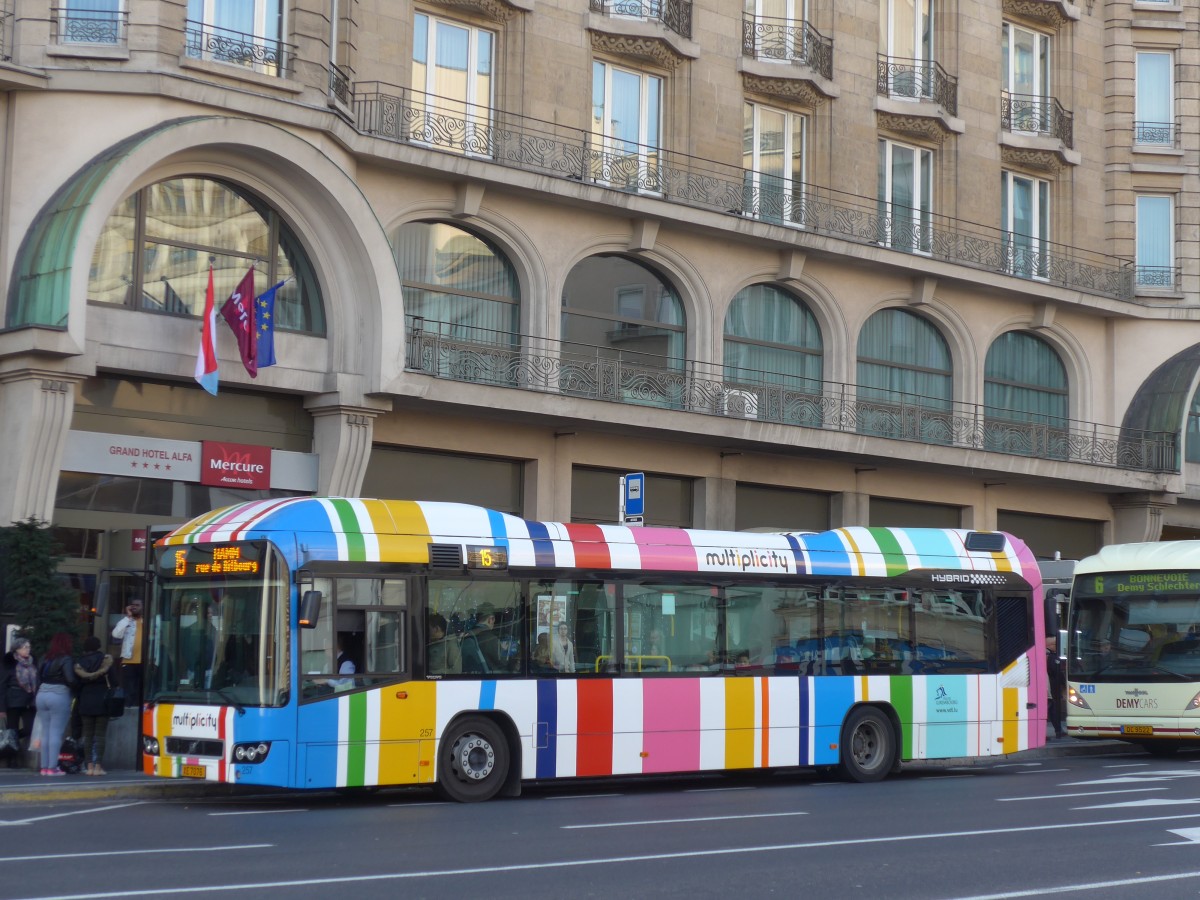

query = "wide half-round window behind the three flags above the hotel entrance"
[{"left": 88, "top": 178, "right": 325, "bottom": 335}]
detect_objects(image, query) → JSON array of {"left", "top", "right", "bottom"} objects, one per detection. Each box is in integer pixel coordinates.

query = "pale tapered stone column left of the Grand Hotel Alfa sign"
[{"left": 0, "top": 368, "right": 80, "bottom": 526}]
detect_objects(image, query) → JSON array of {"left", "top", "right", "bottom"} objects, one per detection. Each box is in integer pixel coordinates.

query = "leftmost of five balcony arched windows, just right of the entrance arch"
[{"left": 394, "top": 222, "right": 521, "bottom": 347}]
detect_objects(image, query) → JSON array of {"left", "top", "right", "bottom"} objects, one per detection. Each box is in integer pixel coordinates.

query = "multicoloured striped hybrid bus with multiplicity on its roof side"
[{"left": 142, "top": 498, "right": 1046, "bottom": 800}]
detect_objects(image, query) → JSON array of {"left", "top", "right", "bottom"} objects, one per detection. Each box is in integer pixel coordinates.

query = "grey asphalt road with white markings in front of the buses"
[{"left": 0, "top": 755, "right": 1200, "bottom": 900}]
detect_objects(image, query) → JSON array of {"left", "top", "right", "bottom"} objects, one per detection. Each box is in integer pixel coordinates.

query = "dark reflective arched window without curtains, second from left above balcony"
[{"left": 562, "top": 254, "right": 686, "bottom": 407}]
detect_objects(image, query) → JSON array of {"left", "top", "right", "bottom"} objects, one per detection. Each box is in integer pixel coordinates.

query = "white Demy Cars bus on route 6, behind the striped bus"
[{"left": 1067, "top": 541, "right": 1200, "bottom": 756}]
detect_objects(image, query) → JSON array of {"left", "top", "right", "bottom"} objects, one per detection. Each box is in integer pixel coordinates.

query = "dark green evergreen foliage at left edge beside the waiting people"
[{"left": 0, "top": 517, "right": 83, "bottom": 656}]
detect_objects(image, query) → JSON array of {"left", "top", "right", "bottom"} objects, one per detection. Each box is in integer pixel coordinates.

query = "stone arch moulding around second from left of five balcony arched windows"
[{"left": 552, "top": 237, "right": 724, "bottom": 372}]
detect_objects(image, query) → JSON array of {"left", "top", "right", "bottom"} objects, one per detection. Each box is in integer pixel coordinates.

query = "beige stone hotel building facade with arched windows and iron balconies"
[{"left": 0, "top": 0, "right": 1200, "bottom": 614}]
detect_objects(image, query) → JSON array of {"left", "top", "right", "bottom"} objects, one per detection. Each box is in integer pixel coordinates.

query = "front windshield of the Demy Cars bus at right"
[{"left": 1067, "top": 594, "right": 1200, "bottom": 682}]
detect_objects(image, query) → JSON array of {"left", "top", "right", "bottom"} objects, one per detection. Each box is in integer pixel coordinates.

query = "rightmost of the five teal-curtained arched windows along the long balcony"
[{"left": 983, "top": 331, "right": 1069, "bottom": 458}]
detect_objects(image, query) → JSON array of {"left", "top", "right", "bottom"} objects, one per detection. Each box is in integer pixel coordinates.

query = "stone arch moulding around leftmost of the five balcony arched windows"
[{"left": 384, "top": 202, "right": 556, "bottom": 336}]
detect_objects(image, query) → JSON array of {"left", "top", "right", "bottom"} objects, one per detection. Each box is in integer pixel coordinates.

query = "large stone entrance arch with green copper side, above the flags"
[{"left": 8, "top": 116, "right": 403, "bottom": 391}]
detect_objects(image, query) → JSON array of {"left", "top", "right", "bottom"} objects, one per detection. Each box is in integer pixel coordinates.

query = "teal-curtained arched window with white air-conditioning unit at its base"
[{"left": 719, "top": 284, "right": 822, "bottom": 426}]
